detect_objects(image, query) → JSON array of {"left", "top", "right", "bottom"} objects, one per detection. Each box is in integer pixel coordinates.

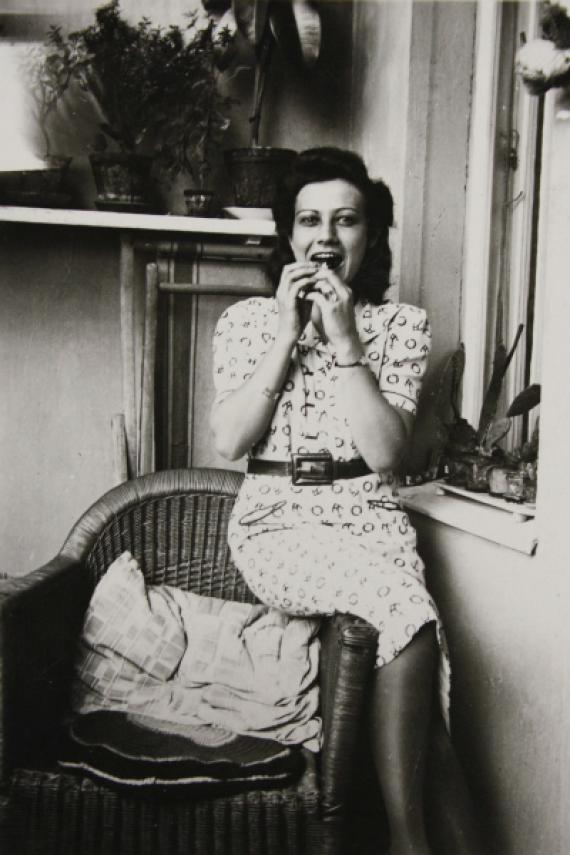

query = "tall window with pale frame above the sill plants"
[{"left": 462, "top": 0, "right": 544, "bottom": 447}]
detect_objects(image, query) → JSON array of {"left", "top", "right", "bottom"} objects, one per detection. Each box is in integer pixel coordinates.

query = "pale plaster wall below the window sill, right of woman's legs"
[{"left": 414, "top": 516, "right": 569, "bottom": 855}]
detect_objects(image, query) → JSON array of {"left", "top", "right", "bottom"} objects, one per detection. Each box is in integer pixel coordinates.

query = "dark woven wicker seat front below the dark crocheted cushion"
[{"left": 8, "top": 771, "right": 317, "bottom": 855}]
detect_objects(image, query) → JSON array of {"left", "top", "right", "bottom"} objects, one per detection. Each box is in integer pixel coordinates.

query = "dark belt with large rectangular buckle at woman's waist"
[{"left": 247, "top": 453, "right": 372, "bottom": 485}]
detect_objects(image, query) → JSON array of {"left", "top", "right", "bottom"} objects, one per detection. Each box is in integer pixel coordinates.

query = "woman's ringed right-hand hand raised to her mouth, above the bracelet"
[{"left": 306, "top": 266, "right": 363, "bottom": 361}]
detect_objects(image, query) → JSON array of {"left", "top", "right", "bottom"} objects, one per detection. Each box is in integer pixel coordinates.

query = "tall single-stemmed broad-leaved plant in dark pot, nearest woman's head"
[{"left": 202, "top": 0, "right": 321, "bottom": 208}]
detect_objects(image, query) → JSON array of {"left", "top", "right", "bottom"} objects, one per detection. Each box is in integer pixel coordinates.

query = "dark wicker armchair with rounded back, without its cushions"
[{"left": 0, "top": 469, "right": 382, "bottom": 855}]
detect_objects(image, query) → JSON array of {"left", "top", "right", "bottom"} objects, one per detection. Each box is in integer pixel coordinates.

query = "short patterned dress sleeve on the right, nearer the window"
[{"left": 380, "top": 305, "right": 431, "bottom": 414}]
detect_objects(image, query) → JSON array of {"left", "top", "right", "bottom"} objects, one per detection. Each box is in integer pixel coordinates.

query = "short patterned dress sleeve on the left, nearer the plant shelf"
[{"left": 213, "top": 298, "right": 274, "bottom": 402}]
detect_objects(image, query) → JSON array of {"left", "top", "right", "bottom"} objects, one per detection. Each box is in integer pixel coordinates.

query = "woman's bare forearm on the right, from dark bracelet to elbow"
[{"left": 337, "top": 365, "right": 412, "bottom": 472}]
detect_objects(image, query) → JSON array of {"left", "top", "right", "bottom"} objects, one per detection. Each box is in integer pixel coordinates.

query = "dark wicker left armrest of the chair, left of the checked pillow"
[{"left": 0, "top": 555, "right": 94, "bottom": 782}]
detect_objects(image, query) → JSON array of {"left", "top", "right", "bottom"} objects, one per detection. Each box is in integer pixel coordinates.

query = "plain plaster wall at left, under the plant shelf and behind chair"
[{"left": 0, "top": 226, "right": 122, "bottom": 575}]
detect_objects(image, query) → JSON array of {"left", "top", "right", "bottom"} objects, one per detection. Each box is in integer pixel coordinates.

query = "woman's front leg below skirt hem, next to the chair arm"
[{"left": 371, "top": 623, "right": 437, "bottom": 855}]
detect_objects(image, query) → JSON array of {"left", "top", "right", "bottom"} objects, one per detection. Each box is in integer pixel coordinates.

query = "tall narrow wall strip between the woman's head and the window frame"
[{"left": 401, "top": 0, "right": 476, "bottom": 471}]
